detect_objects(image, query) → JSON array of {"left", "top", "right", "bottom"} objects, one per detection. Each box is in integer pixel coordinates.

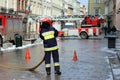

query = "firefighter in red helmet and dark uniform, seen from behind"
[{"left": 40, "top": 18, "right": 61, "bottom": 75}]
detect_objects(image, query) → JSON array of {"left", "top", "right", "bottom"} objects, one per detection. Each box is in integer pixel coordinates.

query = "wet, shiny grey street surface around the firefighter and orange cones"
[{"left": 0, "top": 39, "right": 112, "bottom": 80}]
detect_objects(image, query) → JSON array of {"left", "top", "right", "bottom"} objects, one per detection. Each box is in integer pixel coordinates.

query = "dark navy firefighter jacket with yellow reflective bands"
[{"left": 40, "top": 27, "right": 58, "bottom": 51}]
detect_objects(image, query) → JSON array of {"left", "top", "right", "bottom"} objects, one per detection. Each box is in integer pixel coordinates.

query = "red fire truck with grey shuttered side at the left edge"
[{"left": 0, "top": 14, "right": 25, "bottom": 46}]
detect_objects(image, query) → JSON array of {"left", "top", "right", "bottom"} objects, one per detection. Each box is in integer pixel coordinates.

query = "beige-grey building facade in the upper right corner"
[{"left": 105, "top": 0, "right": 120, "bottom": 30}]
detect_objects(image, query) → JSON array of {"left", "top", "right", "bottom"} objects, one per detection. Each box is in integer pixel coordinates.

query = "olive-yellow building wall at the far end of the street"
[{"left": 88, "top": 0, "right": 105, "bottom": 15}]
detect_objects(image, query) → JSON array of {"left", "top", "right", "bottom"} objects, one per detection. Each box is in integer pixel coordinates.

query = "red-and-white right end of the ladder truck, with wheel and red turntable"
[{"left": 78, "top": 16, "right": 105, "bottom": 39}]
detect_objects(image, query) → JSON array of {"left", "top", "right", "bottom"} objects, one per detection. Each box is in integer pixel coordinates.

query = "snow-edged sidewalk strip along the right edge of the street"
[{"left": 105, "top": 31, "right": 120, "bottom": 80}]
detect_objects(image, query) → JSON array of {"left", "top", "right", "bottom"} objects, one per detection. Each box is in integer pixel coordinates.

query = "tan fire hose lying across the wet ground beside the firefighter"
[{"left": 0, "top": 56, "right": 45, "bottom": 71}]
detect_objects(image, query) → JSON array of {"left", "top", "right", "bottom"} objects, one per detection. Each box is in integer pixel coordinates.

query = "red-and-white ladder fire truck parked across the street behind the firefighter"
[{"left": 53, "top": 16, "right": 105, "bottom": 39}]
